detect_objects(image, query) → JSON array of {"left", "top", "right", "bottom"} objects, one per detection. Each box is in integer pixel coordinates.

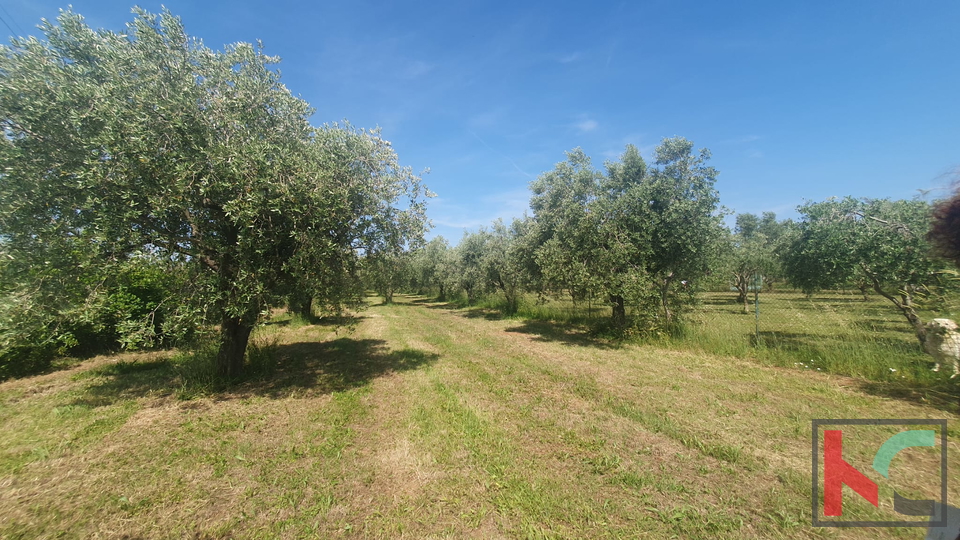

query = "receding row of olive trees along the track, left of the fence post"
[{"left": 401, "top": 138, "right": 725, "bottom": 331}]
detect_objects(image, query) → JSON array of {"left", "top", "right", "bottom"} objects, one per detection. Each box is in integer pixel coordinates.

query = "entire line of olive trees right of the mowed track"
[{"left": 380, "top": 153, "right": 957, "bottom": 358}]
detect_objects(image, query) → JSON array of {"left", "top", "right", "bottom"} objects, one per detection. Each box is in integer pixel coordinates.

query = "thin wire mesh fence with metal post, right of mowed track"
[{"left": 686, "top": 276, "right": 932, "bottom": 379}]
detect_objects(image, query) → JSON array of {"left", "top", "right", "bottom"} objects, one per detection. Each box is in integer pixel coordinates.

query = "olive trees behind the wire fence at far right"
[{"left": 722, "top": 197, "right": 957, "bottom": 349}]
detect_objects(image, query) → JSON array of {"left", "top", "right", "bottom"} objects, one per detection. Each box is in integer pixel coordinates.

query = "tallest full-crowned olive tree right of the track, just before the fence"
[{"left": 531, "top": 138, "right": 723, "bottom": 328}]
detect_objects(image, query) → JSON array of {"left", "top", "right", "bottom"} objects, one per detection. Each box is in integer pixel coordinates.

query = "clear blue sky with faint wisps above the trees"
[{"left": 0, "top": 0, "right": 960, "bottom": 243}]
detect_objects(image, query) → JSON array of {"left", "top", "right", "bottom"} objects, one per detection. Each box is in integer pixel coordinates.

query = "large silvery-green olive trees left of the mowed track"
[{"left": 0, "top": 9, "right": 427, "bottom": 376}]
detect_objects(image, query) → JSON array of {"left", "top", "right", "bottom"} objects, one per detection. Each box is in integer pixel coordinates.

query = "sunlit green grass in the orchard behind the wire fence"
[{"left": 478, "top": 289, "right": 960, "bottom": 413}]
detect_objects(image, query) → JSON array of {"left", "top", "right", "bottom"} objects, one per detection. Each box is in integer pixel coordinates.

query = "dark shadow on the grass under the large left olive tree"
[{"left": 77, "top": 337, "right": 439, "bottom": 406}]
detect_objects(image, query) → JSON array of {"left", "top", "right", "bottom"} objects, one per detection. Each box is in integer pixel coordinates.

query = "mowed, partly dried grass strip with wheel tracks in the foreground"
[{"left": 0, "top": 297, "right": 960, "bottom": 538}]
